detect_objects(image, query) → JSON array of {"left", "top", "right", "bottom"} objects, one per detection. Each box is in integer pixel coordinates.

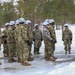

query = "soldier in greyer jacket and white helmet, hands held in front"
[{"left": 43, "top": 22, "right": 55, "bottom": 61}]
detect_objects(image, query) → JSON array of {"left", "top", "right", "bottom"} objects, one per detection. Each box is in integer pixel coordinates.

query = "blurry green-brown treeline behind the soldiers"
[{"left": 0, "top": 0, "right": 75, "bottom": 25}]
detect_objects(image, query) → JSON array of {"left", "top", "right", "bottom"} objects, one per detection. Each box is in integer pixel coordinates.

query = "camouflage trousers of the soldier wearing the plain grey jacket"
[{"left": 44, "top": 40, "right": 53, "bottom": 58}]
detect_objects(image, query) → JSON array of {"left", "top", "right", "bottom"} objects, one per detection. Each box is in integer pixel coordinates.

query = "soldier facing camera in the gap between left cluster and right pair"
[{"left": 33, "top": 24, "right": 42, "bottom": 55}]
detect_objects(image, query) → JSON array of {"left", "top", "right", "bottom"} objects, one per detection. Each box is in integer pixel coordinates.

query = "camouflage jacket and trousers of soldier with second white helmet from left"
[{"left": 7, "top": 26, "right": 16, "bottom": 59}]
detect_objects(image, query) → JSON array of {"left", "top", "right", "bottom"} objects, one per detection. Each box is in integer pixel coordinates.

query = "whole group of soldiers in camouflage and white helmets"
[{"left": 0, "top": 18, "right": 72, "bottom": 66}]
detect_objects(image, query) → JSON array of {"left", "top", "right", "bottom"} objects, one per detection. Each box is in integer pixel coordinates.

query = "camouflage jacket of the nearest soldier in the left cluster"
[{"left": 15, "top": 24, "right": 28, "bottom": 43}]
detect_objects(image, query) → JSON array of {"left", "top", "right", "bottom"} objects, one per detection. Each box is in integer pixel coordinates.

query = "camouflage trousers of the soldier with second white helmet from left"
[{"left": 8, "top": 42, "right": 16, "bottom": 59}]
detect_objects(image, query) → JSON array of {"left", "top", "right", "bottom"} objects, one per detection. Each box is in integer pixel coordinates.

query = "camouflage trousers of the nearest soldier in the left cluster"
[{"left": 18, "top": 42, "right": 29, "bottom": 61}]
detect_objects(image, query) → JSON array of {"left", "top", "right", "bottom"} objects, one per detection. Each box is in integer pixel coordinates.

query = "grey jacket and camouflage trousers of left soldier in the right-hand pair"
[{"left": 43, "top": 28, "right": 53, "bottom": 60}]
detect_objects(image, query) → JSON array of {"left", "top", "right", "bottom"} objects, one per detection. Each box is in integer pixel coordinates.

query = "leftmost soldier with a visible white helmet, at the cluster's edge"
[{"left": 2, "top": 23, "right": 9, "bottom": 57}]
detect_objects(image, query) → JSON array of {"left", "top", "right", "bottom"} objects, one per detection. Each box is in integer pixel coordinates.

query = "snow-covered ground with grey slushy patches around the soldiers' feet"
[{"left": 0, "top": 26, "right": 75, "bottom": 75}]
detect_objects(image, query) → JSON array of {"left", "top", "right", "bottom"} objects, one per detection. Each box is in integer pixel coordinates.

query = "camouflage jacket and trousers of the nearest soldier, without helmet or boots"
[{"left": 16, "top": 24, "right": 29, "bottom": 62}]
